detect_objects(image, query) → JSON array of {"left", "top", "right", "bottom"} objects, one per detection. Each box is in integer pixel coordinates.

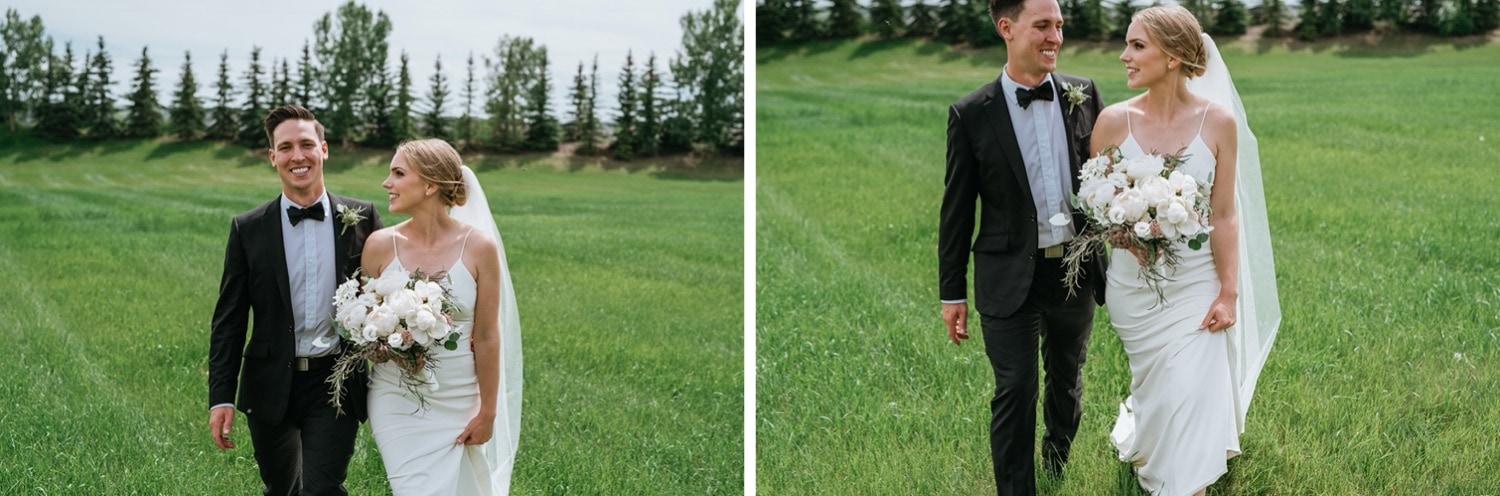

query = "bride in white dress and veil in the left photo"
[{"left": 363, "top": 139, "right": 521, "bottom": 495}]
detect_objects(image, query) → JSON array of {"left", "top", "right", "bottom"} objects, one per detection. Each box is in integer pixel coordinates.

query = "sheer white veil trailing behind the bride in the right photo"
[{"left": 1188, "top": 33, "right": 1281, "bottom": 433}]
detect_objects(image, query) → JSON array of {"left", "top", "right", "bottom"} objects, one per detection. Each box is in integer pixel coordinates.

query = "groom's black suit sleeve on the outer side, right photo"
[{"left": 938, "top": 105, "right": 980, "bottom": 300}]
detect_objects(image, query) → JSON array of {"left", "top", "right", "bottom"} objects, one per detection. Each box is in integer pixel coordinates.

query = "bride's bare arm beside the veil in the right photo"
[{"left": 1199, "top": 105, "right": 1239, "bottom": 331}]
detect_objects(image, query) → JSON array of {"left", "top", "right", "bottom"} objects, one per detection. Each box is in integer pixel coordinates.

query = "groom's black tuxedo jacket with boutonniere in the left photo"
[{"left": 209, "top": 193, "right": 381, "bottom": 424}]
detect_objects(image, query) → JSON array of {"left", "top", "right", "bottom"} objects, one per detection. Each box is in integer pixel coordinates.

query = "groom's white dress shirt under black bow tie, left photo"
[{"left": 281, "top": 192, "right": 339, "bottom": 358}]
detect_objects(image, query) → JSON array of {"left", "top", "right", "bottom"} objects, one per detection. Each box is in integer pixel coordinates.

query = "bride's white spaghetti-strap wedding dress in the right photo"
[{"left": 1106, "top": 104, "right": 1241, "bottom": 496}]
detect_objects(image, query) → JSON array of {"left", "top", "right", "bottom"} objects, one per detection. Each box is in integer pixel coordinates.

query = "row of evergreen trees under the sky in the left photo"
[{"left": 0, "top": 0, "right": 744, "bottom": 159}]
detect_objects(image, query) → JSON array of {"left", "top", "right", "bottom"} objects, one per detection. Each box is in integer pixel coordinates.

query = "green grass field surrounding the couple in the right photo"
[{"left": 756, "top": 37, "right": 1500, "bottom": 495}]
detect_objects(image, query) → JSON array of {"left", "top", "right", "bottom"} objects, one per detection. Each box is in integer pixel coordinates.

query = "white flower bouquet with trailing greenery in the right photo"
[{"left": 1050, "top": 145, "right": 1214, "bottom": 298}]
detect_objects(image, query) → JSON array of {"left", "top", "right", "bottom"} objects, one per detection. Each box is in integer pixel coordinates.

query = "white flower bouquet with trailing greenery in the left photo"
[{"left": 329, "top": 268, "right": 459, "bottom": 411}]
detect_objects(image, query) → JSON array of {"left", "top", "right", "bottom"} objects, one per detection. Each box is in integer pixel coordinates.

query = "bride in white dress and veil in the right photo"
[{"left": 1092, "top": 6, "right": 1281, "bottom": 496}]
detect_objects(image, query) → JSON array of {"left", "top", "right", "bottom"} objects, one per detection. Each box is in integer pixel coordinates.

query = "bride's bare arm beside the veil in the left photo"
[{"left": 458, "top": 237, "right": 500, "bottom": 445}]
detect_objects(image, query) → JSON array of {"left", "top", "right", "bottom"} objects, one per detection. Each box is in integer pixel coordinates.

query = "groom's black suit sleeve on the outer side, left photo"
[{"left": 209, "top": 219, "right": 251, "bottom": 408}]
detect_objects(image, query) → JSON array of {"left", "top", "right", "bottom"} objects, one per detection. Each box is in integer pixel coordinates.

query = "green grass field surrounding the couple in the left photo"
[{"left": 0, "top": 141, "right": 744, "bottom": 495}]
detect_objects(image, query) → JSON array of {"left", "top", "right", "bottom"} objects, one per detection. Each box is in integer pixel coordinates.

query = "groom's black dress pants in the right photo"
[{"left": 980, "top": 252, "right": 1095, "bottom": 496}]
